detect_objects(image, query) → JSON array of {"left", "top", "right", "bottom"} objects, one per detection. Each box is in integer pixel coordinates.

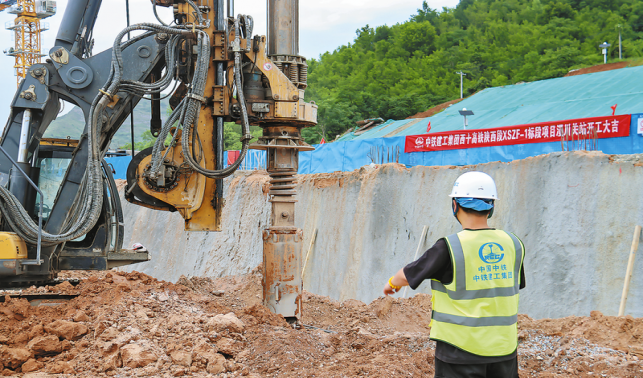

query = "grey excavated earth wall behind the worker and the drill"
[{"left": 119, "top": 152, "right": 643, "bottom": 318}]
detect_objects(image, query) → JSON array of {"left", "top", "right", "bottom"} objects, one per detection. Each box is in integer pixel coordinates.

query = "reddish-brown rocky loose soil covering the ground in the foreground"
[{"left": 0, "top": 268, "right": 643, "bottom": 378}]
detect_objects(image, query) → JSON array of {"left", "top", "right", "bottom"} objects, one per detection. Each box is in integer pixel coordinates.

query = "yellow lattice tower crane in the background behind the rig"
[{"left": 0, "top": 0, "right": 56, "bottom": 84}]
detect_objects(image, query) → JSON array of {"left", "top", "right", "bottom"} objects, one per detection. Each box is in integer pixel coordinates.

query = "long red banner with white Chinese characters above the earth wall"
[{"left": 404, "top": 114, "right": 630, "bottom": 153}]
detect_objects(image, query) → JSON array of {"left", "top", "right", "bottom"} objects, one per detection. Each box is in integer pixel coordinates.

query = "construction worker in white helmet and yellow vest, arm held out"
[{"left": 384, "top": 172, "right": 525, "bottom": 378}]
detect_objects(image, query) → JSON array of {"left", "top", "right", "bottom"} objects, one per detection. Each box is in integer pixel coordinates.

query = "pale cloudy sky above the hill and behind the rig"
[{"left": 0, "top": 0, "right": 458, "bottom": 122}]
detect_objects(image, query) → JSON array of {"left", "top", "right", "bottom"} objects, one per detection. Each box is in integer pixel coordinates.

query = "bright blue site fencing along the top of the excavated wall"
[{"left": 105, "top": 114, "right": 643, "bottom": 179}]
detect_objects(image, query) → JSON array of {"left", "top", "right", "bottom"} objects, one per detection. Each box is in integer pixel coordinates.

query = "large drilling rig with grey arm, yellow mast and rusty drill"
[{"left": 0, "top": 0, "right": 317, "bottom": 320}]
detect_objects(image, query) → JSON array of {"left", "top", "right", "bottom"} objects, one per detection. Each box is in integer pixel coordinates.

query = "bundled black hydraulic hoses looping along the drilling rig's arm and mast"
[{"left": 0, "top": 9, "right": 253, "bottom": 246}]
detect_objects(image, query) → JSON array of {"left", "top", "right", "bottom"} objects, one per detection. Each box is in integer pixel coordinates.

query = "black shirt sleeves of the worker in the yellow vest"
[{"left": 404, "top": 238, "right": 525, "bottom": 290}]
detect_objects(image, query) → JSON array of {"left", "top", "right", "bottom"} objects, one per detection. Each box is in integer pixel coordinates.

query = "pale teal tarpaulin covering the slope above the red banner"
[{"left": 338, "top": 66, "right": 643, "bottom": 142}]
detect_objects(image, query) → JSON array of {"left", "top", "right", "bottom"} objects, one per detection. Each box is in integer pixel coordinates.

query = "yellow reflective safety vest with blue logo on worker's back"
[{"left": 431, "top": 230, "right": 524, "bottom": 357}]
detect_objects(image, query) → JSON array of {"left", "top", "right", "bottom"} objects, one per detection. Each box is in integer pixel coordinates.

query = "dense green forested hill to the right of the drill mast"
[{"left": 304, "top": 0, "right": 643, "bottom": 142}]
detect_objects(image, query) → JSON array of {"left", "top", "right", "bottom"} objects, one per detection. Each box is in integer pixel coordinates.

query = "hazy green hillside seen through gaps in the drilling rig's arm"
[{"left": 44, "top": 100, "right": 169, "bottom": 149}]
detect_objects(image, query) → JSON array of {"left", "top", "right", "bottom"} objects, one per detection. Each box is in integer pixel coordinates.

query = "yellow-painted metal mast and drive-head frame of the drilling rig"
[{"left": 136, "top": 4, "right": 317, "bottom": 231}]
